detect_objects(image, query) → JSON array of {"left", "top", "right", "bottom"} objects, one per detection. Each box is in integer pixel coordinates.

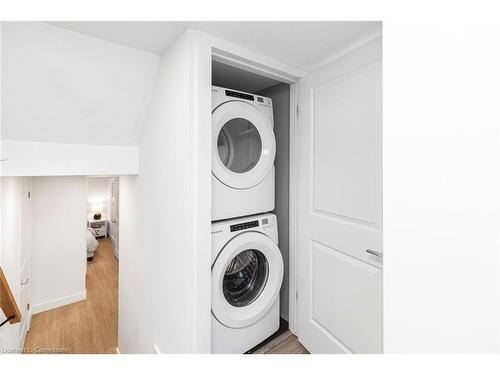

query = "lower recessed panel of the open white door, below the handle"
[{"left": 311, "top": 241, "right": 382, "bottom": 353}]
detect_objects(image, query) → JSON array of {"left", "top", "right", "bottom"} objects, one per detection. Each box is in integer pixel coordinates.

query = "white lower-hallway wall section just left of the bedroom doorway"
[{"left": 31, "top": 177, "right": 87, "bottom": 313}]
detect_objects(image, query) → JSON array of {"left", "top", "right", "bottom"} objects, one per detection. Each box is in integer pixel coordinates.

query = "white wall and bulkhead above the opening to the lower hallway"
[{"left": 1, "top": 22, "right": 160, "bottom": 176}]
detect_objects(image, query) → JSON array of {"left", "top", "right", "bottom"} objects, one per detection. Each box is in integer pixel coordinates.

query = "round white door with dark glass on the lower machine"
[{"left": 212, "top": 232, "right": 283, "bottom": 328}]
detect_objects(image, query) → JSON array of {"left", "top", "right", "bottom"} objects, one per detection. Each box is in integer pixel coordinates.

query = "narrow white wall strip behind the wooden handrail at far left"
[{"left": 0, "top": 177, "right": 22, "bottom": 350}]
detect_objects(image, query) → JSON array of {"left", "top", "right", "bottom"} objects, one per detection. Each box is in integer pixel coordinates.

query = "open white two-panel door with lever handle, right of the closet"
[{"left": 297, "top": 40, "right": 382, "bottom": 353}]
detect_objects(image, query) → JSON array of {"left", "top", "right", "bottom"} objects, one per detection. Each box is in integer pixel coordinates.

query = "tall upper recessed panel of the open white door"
[{"left": 310, "top": 60, "right": 382, "bottom": 226}]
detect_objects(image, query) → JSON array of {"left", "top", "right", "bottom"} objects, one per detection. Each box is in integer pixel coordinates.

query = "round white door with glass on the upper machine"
[{"left": 212, "top": 100, "right": 276, "bottom": 189}]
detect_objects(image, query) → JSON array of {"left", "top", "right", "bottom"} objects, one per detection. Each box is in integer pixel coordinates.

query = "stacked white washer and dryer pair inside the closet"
[{"left": 212, "top": 86, "right": 283, "bottom": 353}]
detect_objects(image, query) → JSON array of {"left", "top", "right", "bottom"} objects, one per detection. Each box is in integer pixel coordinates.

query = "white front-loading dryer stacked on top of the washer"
[{"left": 212, "top": 86, "right": 276, "bottom": 221}]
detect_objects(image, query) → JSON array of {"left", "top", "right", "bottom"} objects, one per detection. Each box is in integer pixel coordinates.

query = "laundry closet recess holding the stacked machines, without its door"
[{"left": 212, "top": 59, "right": 290, "bottom": 353}]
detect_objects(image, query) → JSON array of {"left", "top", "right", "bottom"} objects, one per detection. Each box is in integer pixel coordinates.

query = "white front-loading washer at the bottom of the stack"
[{"left": 212, "top": 214, "right": 283, "bottom": 353}]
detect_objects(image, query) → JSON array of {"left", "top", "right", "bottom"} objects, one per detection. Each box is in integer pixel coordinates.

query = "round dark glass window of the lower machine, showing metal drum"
[{"left": 222, "top": 249, "right": 269, "bottom": 307}]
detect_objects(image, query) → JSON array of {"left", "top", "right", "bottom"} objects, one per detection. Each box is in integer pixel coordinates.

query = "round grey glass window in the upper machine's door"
[{"left": 217, "top": 117, "right": 262, "bottom": 173}]
